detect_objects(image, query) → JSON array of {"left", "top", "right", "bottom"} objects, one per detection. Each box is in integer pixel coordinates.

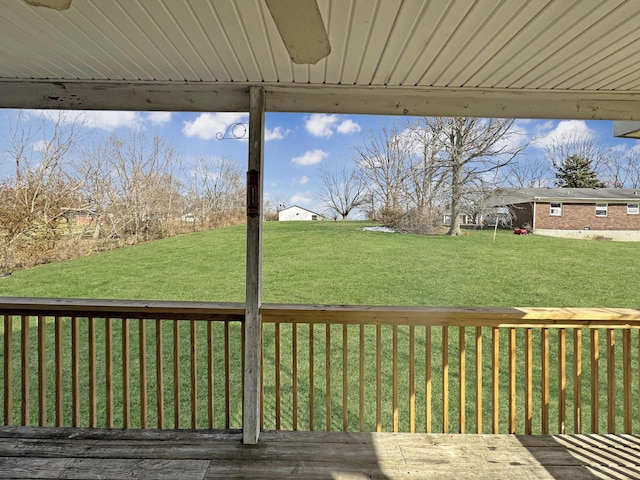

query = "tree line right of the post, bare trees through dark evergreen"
[{"left": 319, "top": 117, "right": 640, "bottom": 235}]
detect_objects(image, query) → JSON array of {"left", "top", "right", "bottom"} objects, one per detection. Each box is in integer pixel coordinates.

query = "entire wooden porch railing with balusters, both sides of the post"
[{"left": 0, "top": 298, "right": 640, "bottom": 434}]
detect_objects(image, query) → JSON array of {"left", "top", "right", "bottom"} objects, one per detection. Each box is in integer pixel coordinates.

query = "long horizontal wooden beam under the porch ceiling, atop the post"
[{"left": 0, "top": 79, "right": 640, "bottom": 121}]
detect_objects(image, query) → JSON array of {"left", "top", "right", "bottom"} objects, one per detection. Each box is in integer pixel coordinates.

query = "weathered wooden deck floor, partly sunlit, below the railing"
[{"left": 0, "top": 427, "right": 640, "bottom": 480}]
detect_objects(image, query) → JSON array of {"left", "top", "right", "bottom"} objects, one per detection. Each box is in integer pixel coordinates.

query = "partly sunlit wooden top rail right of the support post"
[{"left": 261, "top": 304, "right": 640, "bottom": 328}]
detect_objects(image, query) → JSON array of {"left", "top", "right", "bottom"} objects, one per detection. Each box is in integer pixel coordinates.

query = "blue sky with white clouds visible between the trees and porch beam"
[{"left": 0, "top": 110, "right": 640, "bottom": 215}]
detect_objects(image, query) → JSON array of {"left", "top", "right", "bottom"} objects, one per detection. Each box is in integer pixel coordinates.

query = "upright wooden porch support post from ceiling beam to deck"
[{"left": 242, "top": 87, "right": 265, "bottom": 445}]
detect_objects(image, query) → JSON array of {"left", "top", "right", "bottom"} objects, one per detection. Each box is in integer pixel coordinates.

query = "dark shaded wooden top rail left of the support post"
[{"left": 0, "top": 297, "right": 244, "bottom": 321}]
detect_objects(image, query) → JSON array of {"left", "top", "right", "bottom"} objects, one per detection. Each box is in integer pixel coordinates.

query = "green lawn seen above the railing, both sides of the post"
[{"left": 0, "top": 222, "right": 640, "bottom": 307}]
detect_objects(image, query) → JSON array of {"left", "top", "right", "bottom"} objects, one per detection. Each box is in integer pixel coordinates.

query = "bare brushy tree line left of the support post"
[{"left": 0, "top": 112, "right": 245, "bottom": 272}]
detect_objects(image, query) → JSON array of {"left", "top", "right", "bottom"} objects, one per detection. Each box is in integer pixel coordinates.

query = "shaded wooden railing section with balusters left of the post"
[{"left": 0, "top": 298, "right": 244, "bottom": 428}]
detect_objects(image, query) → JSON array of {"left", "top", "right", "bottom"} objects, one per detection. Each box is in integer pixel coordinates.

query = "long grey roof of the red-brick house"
[{"left": 490, "top": 188, "right": 640, "bottom": 206}]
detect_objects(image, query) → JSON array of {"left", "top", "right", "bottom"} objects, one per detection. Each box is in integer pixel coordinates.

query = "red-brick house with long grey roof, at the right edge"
[{"left": 489, "top": 188, "right": 640, "bottom": 241}]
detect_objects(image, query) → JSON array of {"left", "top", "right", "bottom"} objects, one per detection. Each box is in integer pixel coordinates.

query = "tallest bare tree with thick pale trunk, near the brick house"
[{"left": 424, "top": 117, "right": 526, "bottom": 235}]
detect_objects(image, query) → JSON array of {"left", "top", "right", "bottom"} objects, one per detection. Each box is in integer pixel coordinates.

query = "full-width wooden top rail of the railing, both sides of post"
[{"left": 0, "top": 297, "right": 640, "bottom": 328}]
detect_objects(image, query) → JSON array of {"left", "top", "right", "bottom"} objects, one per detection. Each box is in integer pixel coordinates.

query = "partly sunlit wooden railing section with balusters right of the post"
[{"left": 262, "top": 305, "right": 640, "bottom": 434}]
